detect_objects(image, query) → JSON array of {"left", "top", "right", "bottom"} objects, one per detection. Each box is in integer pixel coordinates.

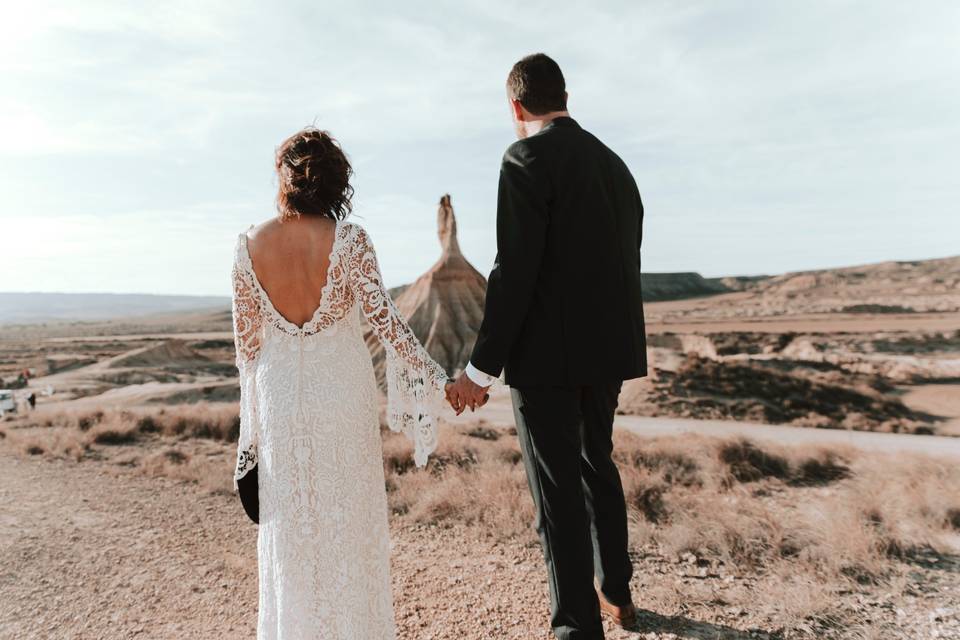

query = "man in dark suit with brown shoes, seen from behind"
[{"left": 449, "top": 53, "right": 647, "bottom": 640}]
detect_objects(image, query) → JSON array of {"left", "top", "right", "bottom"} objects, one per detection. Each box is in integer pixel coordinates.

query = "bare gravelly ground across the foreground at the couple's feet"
[{"left": 0, "top": 428, "right": 960, "bottom": 640}]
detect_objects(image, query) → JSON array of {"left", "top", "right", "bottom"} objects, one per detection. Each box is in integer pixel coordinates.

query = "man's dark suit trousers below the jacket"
[{"left": 511, "top": 382, "right": 633, "bottom": 640}]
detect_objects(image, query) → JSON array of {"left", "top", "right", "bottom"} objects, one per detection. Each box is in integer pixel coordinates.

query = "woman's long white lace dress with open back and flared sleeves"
[{"left": 233, "top": 222, "right": 447, "bottom": 640}]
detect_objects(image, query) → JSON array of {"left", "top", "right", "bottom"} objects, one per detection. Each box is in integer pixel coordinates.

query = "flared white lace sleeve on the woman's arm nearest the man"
[{"left": 350, "top": 226, "right": 447, "bottom": 467}]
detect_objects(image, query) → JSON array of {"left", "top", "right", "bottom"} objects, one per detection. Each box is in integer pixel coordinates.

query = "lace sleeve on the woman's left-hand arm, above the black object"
[{"left": 232, "top": 235, "right": 263, "bottom": 489}]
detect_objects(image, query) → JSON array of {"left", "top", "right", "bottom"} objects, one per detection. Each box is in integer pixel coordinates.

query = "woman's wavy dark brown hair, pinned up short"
[{"left": 277, "top": 127, "right": 353, "bottom": 221}]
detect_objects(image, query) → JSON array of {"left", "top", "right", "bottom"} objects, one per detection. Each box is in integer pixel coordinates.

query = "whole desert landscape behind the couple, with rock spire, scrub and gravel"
[{"left": 0, "top": 201, "right": 960, "bottom": 640}]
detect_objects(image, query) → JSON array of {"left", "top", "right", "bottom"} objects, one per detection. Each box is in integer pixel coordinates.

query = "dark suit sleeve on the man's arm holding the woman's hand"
[{"left": 470, "top": 145, "right": 549, "bottom": 377}]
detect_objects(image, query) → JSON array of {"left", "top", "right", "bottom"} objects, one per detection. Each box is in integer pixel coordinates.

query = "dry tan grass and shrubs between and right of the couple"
[{"left": 384, "top": 427, "right": 960, "bottom": 596}]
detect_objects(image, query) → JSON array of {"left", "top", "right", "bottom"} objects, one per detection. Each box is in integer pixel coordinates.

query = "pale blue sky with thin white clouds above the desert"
[{"left": 0, "top": 0, "right": 960, "bottom": 295}]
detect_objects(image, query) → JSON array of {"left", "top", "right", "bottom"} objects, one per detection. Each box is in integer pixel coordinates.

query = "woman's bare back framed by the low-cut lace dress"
[{"left": 247, "top": 216, "right": 336, "bottom": 327}]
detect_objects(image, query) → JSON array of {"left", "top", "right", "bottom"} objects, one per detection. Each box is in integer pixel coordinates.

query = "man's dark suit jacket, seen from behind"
[{"left": 470, "top": 117, "right": 647, "bottom": 386}]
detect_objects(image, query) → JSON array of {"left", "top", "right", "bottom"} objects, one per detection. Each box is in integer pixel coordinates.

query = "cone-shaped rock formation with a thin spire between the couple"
[{"left": 367, "top": 195, "right": 487, "bottom": 384}]
